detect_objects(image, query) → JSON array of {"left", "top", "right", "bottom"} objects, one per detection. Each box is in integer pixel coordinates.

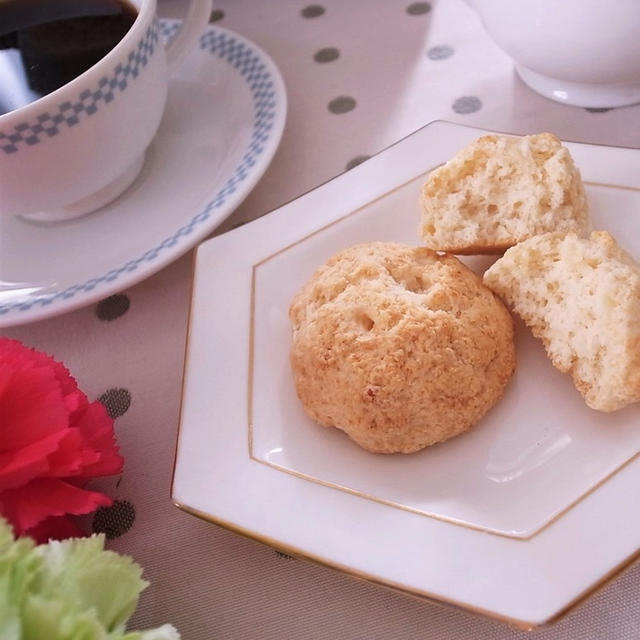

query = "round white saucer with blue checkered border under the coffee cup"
[{"left": 0, "top": 20, "right": 286, "bottom": 326}]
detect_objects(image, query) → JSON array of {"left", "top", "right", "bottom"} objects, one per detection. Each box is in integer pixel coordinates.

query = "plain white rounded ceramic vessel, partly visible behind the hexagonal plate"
[{"left": 467, "top": 0, "right": 640, "bottom": 107}]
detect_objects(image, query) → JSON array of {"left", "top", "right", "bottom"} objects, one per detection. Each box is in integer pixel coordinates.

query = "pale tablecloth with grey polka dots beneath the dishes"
[{"left": 4, "top": 0, "right": 640, "bottom": 640}]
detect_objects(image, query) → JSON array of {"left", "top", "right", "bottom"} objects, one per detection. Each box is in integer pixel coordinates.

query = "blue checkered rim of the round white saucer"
[{"left": 0, "top": 18, "right": 288, "bottom": 328}]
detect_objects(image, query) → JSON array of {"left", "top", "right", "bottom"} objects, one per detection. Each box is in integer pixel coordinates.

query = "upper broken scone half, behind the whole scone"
[{"left": 418, "top": 133, "right": 591, "bottom": 255}]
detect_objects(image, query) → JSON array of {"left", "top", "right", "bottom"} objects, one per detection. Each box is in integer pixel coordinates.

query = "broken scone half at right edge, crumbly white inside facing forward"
[{"left": 484, "top": 231, "right": 640, "bottom": 411}]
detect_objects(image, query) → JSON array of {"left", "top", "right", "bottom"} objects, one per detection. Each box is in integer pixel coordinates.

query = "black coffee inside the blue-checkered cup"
[{"left": 0, "top": 0, "right": 138, "bottom": 114}]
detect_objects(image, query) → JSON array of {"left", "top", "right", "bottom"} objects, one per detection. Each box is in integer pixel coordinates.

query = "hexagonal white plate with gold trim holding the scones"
[{"left": 172, "top": 122, "right": 640, "bottom": 627}]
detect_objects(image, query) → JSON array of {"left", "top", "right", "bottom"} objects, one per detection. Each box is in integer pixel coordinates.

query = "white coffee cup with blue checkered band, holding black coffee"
[{"left": 0, "top": 0, "right": 211, "bottom": 220}]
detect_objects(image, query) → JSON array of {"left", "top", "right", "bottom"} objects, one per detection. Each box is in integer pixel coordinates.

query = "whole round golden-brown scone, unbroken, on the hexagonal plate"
[{"left": 289, "top": 242, "right": 515, "bottom": 453}]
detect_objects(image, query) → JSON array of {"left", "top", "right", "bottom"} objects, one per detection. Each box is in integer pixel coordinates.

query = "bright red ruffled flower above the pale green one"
[{"left": 0, "top": 338, "right": 123, "bottom": 542}]
